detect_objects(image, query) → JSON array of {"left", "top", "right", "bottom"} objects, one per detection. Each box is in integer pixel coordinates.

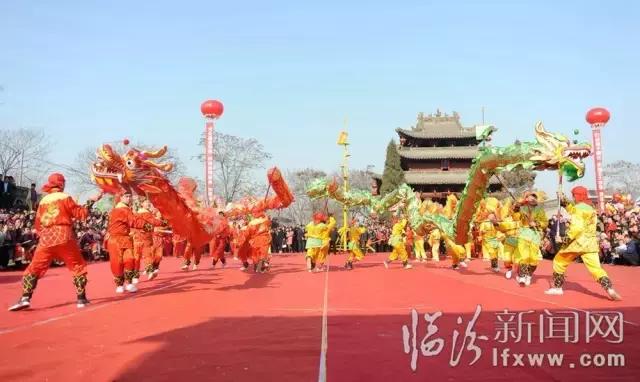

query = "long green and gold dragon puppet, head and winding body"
[{"left": 307, "top": 122, "right": 591, "bottom": 245}]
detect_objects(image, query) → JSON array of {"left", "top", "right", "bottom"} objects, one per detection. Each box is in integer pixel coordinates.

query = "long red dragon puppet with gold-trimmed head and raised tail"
[{"left": 91, "top": 144, "right": 293, "bottom": 274}]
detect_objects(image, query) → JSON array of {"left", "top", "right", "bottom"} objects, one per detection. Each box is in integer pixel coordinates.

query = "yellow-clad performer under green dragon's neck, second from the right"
[{"left": 514, "top": 192, "right": 549, "bottom": 286}]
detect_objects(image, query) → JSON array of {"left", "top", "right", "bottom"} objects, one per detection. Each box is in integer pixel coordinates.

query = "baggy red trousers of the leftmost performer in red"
[{"left": 24, "top": 240, "right": 87, "bottom": 278}]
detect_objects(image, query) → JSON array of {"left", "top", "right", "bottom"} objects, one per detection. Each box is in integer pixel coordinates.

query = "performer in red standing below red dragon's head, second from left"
[{"left": 107, "top": 192, "right": 153, "bottom": 293}]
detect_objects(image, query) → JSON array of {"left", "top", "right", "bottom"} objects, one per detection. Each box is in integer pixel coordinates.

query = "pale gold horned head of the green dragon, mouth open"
[{"left": 531, "top": 122, "right": 591, "bottom": 181}]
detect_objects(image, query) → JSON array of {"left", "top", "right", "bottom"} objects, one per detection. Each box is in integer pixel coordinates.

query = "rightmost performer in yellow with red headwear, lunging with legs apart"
[{"left": 545, "top": 186, "right": 622, "bottom": 300}]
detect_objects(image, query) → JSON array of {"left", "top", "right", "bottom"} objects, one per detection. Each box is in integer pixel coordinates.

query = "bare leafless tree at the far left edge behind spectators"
[{"left": 0, "top": 129, "right": 51, "bottom": 186}]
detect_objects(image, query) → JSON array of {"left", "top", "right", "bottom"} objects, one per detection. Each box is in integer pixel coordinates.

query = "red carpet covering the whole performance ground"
[{"left": 0, "top": 255, "right": 640, "bottom": 381}]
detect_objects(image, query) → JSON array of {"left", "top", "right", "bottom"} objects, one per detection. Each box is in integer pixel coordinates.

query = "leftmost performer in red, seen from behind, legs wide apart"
[{"left": 9, "top": 173, "right": 93, "bottom": 311}]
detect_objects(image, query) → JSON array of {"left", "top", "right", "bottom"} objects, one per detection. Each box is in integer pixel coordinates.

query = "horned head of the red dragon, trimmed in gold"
[{"left": 91, "top": 144, "right": 173, "bottom": 194}]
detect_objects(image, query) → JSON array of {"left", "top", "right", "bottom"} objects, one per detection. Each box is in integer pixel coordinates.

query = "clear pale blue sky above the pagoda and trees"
[{"left": 0, "top": 1, "right": 640, "bottom": 197}]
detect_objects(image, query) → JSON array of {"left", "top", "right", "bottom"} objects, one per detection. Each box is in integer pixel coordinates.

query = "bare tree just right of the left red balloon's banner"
[{"left": 198, "top": 132, "right": 271, "bottom": 203}]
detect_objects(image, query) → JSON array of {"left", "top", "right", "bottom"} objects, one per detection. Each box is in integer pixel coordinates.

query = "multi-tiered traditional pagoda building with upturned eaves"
[{"left": 396, "top": 110, "right": 502, "bottom": 201}]
